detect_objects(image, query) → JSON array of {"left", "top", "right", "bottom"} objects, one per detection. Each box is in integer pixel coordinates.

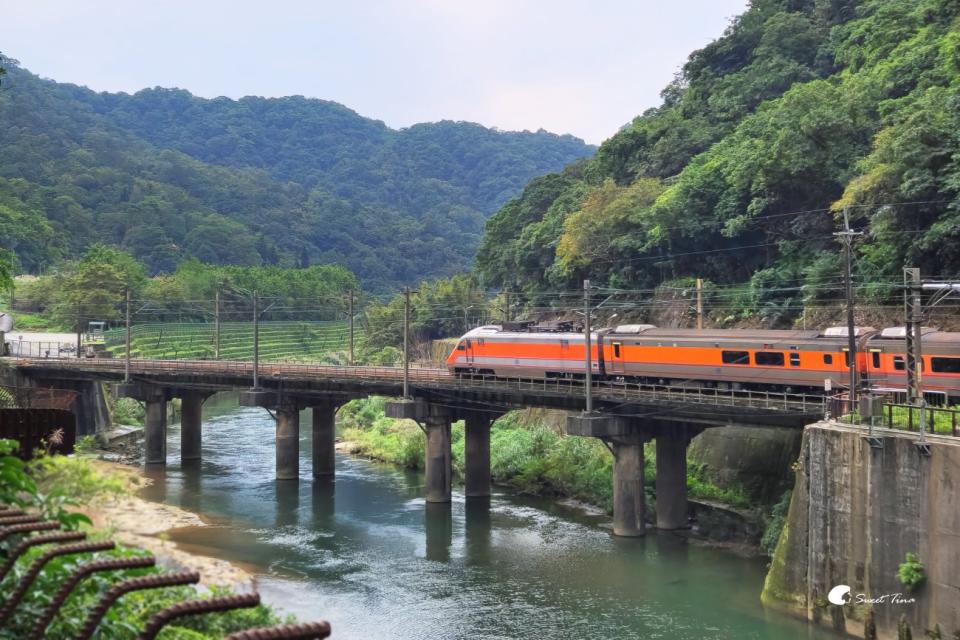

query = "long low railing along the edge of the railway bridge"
[{"left": 11, "top": 358, "right": 826, "bottom": 416}]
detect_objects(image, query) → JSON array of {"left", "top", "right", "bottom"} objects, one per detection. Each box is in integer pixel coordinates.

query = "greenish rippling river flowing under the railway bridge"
[{"left": 144, "top": 398, "right": 834, "bottom": 640}]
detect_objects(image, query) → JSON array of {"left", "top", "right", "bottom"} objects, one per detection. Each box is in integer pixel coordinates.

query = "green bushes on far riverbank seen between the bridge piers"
[{"left": 338, "top": 398, "right": 749, "bottom": 512}]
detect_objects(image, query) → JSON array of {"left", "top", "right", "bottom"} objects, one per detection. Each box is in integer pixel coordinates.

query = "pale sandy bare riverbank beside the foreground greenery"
[{"left": 78, "top": 458, "right": 256, "bottom": 591}]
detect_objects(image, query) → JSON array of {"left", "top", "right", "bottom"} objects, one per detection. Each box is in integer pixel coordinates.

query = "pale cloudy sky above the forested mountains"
[{"left": 0, "top": 0, "right": 747, "bottom": 144}]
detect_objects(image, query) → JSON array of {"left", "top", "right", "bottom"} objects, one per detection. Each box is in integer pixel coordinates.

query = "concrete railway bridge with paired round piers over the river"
[{"left": 5, "top": 358, "right": 824, "bottom": 536}]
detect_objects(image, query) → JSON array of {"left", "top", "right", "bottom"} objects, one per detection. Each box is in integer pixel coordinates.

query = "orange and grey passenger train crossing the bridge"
[{"left": 446, "top": 323, "right": 960, "bottom": 404}]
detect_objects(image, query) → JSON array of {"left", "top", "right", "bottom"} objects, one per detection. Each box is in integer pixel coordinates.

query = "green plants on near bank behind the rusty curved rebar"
[{"left": 0, "top": 440, "right": 281, "bottom": 640}]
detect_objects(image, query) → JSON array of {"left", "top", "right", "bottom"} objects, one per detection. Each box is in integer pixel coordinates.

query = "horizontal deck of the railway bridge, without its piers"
[{"left": 7, "top": 358, "right": 824, "bottom": 425}]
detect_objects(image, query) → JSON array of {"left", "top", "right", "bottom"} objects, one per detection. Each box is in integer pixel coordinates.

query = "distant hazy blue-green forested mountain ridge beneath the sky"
[{"left": 0, "top": 60, "right": 593, "bottom": 290}]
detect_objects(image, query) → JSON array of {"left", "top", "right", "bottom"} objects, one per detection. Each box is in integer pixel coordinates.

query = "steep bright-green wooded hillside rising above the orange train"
[{"left": 477, "top": 0, "right": 960, "bottom": 319}]
